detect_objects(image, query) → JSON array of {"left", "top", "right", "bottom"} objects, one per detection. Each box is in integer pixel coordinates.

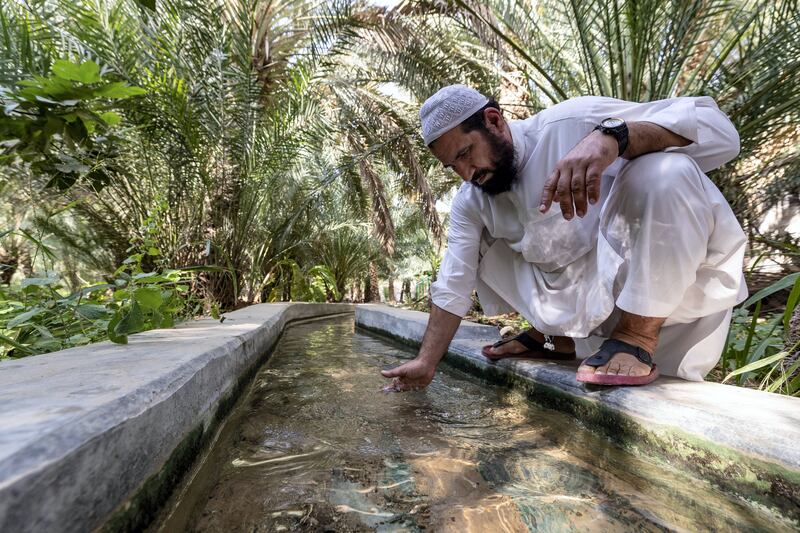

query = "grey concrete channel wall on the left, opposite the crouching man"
[{"left": 0, "top": 304, "right": 353, "bottom": 532}]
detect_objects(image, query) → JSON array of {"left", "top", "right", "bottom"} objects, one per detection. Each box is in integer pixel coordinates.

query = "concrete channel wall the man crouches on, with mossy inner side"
[{"left": 356, "top": 305, "right": 800, "bottom": 523}]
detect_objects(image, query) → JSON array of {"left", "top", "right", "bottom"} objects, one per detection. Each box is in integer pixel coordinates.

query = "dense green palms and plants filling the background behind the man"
[{"left": 0, "top": 0, "right": 800, "bottom": 393}]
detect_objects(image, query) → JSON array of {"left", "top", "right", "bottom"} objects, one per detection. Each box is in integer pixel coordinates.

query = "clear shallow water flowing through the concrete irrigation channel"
[{"left": 158, "top": 317, "right": 790, "bottom": 532}]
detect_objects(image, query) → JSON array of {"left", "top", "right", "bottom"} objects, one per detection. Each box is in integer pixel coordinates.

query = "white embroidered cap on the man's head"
[{"left": 419, "top": 85, "right": 489, "bottom": 145}]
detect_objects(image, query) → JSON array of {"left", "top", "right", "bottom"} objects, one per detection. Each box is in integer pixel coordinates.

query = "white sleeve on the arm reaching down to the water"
[{"left": 431, "top": 190, "right": 483, "bottom": 317}]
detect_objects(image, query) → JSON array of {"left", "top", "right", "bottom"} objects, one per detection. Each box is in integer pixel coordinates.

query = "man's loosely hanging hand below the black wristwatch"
[{"left": 539, "top": 131, "right": 619, "bottom": 220}]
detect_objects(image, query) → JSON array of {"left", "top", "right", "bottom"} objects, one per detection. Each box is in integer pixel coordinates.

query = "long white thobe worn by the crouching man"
[{"left": 431, "top": 97, "right": 747, "bottom": 380}]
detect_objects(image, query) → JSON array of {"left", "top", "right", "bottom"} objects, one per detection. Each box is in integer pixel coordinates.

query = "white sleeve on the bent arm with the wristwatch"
[{"left": 579, "top": 96, "right": 739, "bottom": 172}]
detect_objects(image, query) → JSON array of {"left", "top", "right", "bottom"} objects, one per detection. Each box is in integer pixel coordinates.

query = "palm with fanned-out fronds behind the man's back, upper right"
[{"left": 420, "top": 0, "right": 800, "bottom": 232}]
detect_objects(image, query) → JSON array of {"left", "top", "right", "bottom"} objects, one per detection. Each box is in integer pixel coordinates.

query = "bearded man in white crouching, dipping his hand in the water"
[{"left": 382, "top": 85, "right": 747, "bottom": 391}]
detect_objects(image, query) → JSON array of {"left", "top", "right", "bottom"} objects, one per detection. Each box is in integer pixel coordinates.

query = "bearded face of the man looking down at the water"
[{"left": 431, "top": 120, "right": 517, "bottom": 195}]
